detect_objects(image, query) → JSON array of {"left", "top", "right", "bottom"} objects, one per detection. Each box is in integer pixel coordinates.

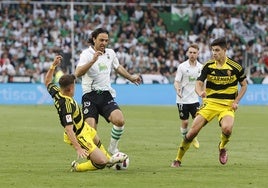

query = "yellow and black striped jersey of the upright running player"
[{"left": 197, "top": 57, "right": 246, "bottom": 100}]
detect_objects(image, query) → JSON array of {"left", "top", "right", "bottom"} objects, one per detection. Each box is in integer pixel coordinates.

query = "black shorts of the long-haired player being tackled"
[{"left": 82, "top": 91, "right": 120, "bottom": 123}]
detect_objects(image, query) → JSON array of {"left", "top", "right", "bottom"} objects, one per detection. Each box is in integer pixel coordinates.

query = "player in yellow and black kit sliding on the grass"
[{"left": 45, "top": 55, "right": 127, "bottom": 172}]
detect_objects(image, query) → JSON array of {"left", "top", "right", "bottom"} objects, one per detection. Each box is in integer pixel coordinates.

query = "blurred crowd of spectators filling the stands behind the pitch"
[{"left": 0, "top": 0, "right": 268, "bottom": 83}]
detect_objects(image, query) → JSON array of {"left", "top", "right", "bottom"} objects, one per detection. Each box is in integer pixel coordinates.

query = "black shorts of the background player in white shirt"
[{"left": 177, "top": 102, "right": 200, "bottom": 120}]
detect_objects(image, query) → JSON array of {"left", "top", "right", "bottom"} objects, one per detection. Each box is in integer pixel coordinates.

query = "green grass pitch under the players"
[{"left": 0, "top": 106, "right": 268, "bottom": 188}]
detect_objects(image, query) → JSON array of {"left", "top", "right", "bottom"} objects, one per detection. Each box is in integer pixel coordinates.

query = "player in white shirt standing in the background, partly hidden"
[{"left": 174, "top": 44, "right": 203, "bottom": 163}]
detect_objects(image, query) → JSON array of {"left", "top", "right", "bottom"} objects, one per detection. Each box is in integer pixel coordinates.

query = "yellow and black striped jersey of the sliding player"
[{"left": 47, "top": 83, "right": 84, "bottom": 135}]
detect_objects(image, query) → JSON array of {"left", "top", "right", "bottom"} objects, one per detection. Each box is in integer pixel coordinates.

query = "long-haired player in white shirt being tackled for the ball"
[{"left": 75, "top": 28, "right": 141, "bottom": 154}]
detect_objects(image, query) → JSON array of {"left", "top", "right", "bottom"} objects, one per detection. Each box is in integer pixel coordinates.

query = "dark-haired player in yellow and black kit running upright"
[{"left": 171, "top": 38, "right": 247, "bottom": 167}]
